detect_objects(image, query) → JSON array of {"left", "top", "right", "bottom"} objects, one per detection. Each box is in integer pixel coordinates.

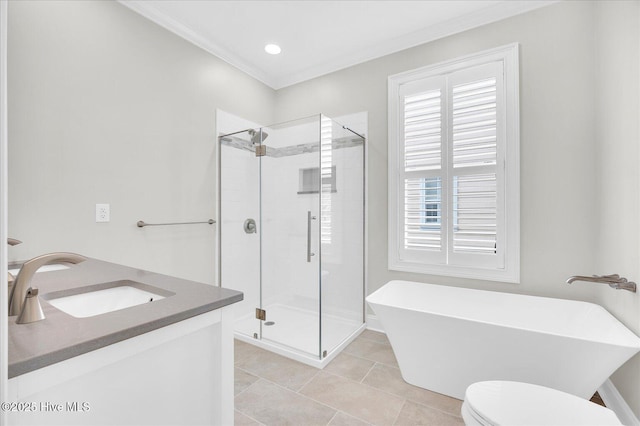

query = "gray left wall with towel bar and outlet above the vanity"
[{"left": 8, "top": 1, "right": 275, "bottom": 283}]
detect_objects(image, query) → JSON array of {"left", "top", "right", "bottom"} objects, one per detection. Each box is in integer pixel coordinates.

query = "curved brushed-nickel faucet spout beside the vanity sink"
[{"left": 9, "top": 252, "right": 87, "bottom": 322}]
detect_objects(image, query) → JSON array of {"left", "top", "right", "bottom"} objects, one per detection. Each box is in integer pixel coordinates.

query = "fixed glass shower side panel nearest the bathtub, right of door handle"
[{"left": 320, "top": 116, "right": 364, "bottom": 353}]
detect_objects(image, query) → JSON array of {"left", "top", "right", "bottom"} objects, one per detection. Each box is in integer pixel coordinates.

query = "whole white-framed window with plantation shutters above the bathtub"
[{"left": 389, "top": 44, "right": 520, "bottom": 282}]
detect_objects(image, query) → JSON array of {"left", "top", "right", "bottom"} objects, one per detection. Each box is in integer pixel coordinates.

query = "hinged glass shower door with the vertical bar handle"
[{"left": 260, "top": 116, "right": 320, "bottom": 358}]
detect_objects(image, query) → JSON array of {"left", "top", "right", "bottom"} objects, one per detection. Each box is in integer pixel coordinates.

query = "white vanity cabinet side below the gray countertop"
[{"left": 8, "top": 307, "right": 233, "bottom": 426}]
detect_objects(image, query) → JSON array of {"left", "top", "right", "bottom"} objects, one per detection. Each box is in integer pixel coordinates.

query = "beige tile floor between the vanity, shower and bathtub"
[{"left": 235, "top": 330, "right": 464, "bottom": 426}]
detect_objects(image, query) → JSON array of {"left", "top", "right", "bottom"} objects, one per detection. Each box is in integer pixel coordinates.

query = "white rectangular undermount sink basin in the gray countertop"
[{"left": 45, "top": 285, "right": 165, "bottom": 318}]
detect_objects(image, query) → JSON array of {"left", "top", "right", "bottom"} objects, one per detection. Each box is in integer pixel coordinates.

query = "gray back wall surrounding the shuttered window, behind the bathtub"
[{"left": 276, "top": 2, "right": 598, "bottom": 299}]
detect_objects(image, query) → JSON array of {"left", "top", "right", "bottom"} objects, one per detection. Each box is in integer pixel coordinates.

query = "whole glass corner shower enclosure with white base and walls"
[{"left": 218, "top": 115, "right": 365, "bottom": 367}]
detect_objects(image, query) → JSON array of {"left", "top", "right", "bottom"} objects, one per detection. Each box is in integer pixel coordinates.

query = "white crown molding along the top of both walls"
[{"left": 118, "top": 0, "right": 559, "bottom": 90}]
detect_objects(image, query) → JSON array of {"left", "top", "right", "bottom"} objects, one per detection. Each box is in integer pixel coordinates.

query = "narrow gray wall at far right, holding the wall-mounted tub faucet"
[{"left": 595, "top": 2, "right": 640, "bottom": 417}]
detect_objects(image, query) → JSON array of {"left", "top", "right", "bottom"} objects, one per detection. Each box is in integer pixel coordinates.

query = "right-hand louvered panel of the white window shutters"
[{"left": 448, "top": 63, "right": 505, "bottom": 268}]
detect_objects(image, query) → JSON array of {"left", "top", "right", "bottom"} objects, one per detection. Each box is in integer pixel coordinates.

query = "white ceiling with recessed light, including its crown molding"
[{"left": 120, "top": 0, "right": 554, "bottom": 89}]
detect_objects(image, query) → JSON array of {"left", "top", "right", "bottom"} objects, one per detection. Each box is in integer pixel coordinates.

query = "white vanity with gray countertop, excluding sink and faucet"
[{"left": 3, "top": 259, "right": 242, "bottom": 426}]
